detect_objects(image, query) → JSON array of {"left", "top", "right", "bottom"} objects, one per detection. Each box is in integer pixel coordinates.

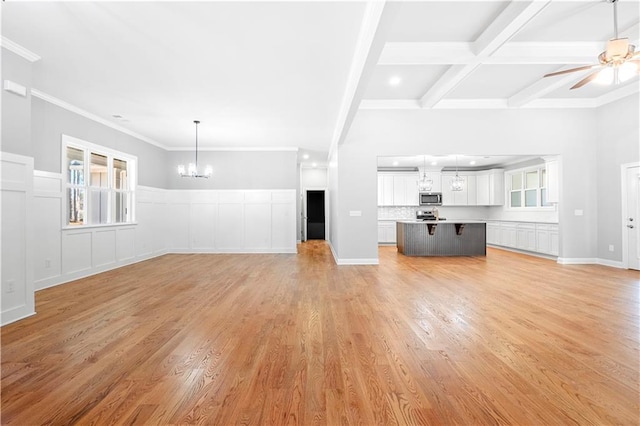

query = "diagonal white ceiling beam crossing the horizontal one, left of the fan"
[{"left": 420, "top": 0, "right": 550, "bottom": 108}]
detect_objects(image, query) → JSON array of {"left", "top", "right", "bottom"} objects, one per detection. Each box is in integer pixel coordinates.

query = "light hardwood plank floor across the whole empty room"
[{"left": 1, "top": 242, "right": 640, "bottom": 425}]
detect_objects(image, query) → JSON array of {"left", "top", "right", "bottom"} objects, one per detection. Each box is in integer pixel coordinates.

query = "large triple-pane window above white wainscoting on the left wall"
[{"left": 63, "top": 136, "right": 137, "bottom": 226}]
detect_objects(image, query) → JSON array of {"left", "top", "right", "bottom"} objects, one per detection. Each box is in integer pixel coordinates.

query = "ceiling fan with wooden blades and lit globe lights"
[{"left": 544, "top": 0, "right": 640, "bottom": 89}]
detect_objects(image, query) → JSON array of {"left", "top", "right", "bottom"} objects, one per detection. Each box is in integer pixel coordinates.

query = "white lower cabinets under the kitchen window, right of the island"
[{"left": 487, "top": 222, "right": 559, "bottom": 256}]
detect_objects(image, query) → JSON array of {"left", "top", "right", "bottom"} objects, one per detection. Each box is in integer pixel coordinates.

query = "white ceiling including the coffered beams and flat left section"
[{"left": 2, "top": 0, "right": 640, "bottom": 168}]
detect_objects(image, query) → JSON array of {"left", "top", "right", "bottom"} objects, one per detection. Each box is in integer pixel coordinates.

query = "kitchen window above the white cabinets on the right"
[{"left": 506, "top": 165, "right": 553, "bottom": 209}]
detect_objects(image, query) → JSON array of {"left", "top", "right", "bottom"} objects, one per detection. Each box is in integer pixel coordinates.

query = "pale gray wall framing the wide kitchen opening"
[{"left": 332, "top": 109, "right": 604, "bottom": 260}]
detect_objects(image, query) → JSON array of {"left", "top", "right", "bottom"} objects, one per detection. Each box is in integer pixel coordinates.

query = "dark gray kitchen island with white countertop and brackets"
[{"left": 396, "top": 220, "right": 487, "bottom": 256}]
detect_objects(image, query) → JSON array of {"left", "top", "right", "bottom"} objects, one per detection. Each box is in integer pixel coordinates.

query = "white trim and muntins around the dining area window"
[{"left": 60, "top": 134, "right": 138, "bottom": 230}]
